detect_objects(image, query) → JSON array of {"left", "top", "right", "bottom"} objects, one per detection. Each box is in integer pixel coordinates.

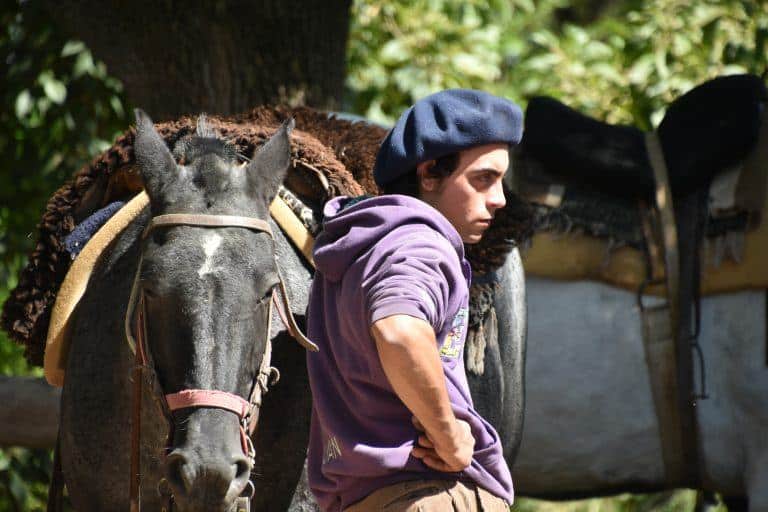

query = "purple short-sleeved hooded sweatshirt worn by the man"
[{"left": 307, "top": 195, "right": 513, "bottom": 511}]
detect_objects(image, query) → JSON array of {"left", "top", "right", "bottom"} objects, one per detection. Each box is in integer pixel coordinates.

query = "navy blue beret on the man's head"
[{"left": 373, "top": 89, "right": 523, "bottom": 186}]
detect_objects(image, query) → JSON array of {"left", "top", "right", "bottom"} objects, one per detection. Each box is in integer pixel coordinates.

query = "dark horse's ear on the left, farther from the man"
[{"left": 133, "top": 108, "right": 176, "bottom": 199}]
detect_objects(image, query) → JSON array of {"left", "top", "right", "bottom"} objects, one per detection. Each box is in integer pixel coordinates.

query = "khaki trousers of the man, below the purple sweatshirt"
[{"left": 345, "top": 480, "right": 509, "bottom": 512}]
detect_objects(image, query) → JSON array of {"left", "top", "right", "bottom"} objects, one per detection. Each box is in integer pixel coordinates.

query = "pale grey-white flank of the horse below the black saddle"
[{"left": 513, "top": 276, "right": 768, "bottom": 511}]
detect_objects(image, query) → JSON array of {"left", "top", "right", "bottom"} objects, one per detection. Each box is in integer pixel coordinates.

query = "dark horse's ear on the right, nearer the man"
[{"left": 246, "top": 118, "right": 296, "bottom": 202}]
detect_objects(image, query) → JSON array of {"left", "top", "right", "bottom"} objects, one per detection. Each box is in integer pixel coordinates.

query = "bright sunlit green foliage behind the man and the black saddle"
[{"left": 347, "top": 0, "right": 768, "bottom": 129}]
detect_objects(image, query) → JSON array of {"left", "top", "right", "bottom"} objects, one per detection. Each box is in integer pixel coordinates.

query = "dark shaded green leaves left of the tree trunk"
[{"left": 0, "top": 2, "right": 128, "bottom": 268}]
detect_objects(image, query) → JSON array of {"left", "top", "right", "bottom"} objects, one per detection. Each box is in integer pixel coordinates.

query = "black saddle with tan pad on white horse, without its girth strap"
[{"left": 512, "top": 75, "right": 768, "bottom": 295}]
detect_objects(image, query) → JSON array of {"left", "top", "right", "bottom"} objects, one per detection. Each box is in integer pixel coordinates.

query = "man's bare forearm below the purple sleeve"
[{"left": 371, "top": 315, "right": 456, "bottom": 438}]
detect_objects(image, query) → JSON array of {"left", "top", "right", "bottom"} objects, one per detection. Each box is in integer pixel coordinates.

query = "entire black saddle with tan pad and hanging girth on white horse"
[{"left": 513, "top": 75, "right": 768, "bottom": 487}]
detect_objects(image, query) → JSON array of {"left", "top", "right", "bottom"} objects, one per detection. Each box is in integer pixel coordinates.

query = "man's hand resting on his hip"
[{"left": 411, "top": 416, "right": 475, "bottom": 473}]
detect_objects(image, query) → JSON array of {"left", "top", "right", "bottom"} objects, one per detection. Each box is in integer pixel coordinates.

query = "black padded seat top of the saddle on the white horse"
[{"left": 519, "top": 75, "right": 767, "bottom": 198}]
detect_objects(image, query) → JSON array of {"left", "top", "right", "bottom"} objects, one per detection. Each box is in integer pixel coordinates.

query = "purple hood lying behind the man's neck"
[{"left": 313, "top": 194, "right": 464, "bottom": 282}]
